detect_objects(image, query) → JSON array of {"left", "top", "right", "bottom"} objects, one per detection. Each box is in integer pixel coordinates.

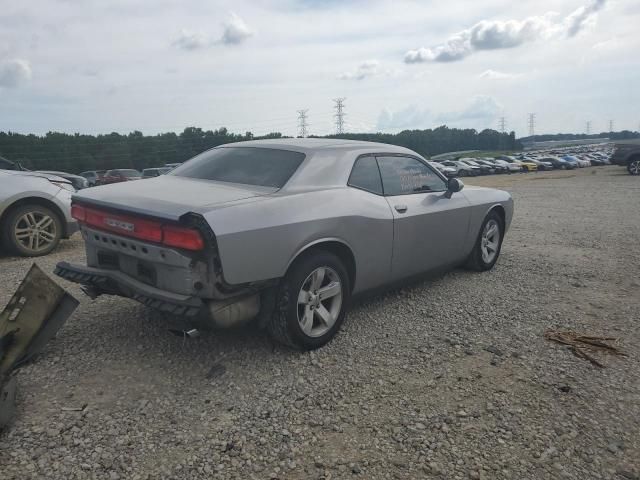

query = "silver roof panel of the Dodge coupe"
[{"left": 216, "top": 138, "right": 415, "bottom": 155}]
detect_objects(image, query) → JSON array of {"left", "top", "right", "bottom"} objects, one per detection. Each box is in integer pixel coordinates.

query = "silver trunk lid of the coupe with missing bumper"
[{"left": 73, "top": 175, "right": 277, "bottom": 221}]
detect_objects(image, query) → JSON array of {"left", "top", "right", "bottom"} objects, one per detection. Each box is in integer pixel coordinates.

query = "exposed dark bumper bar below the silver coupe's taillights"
[{"left": 55, "top": 262, "right": 203, "bottom": 316}]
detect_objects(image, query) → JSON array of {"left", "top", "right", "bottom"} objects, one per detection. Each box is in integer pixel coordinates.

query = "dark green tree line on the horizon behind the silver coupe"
[{"left": 0, "top": 126, "right": 522, "bottom": 173}]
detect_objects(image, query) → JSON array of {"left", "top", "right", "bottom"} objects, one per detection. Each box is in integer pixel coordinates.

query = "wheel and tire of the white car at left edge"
[{"left": 2, "top": 204, "right": 63, "bottom": 257}]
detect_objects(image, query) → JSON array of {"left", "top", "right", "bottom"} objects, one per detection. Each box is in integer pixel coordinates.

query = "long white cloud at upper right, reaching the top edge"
[{"left": 404, "top": 0, "right": 606, "bottom": 63}]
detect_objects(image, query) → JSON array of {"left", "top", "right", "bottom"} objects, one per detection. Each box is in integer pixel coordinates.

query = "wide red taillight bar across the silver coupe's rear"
[{"left": 71, "top": 204, "right": 204, "bottom": 250}]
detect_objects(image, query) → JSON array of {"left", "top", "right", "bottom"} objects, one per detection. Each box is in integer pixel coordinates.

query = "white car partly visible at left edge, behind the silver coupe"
[{"left": 0, "top": 170, "right": 78, "bottom": 257}]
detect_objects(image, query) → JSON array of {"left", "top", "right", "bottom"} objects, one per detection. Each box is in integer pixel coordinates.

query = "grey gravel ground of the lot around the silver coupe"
[{"left": 0, "top": 167, "right": 640, "bottom": 480}]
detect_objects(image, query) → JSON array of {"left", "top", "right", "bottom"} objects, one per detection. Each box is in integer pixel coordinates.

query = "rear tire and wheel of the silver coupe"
[{"left": 267, "top": 250, "right": 351, "bottom": 350}]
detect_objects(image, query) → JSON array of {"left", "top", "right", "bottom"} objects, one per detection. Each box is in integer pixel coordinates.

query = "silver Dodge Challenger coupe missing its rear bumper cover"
[{"left": 56, "top": 139, "right": 513, "bottom": 349}]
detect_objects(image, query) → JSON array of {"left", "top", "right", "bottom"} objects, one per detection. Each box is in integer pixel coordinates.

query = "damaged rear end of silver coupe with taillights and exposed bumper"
[{"left": 56, "top": 199, "right": 214, "bottom": 315}]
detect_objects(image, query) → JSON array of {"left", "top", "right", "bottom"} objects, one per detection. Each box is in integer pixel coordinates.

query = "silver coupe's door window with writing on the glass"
[{"left": 378, "top": 157, "right": 447, "bottom": 195}]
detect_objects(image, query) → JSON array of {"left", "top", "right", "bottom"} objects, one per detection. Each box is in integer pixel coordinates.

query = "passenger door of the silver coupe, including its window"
[{"left": 377, "top": 155, "right": 470, "bottom": 280}]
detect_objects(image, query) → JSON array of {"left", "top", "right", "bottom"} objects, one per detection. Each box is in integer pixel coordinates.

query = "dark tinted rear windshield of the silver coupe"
[{"left": 169, "top": 147, "right": 305, "bottom": 188}]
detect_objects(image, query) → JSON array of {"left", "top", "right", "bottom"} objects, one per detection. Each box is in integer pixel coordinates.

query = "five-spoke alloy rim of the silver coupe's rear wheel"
[{"left": 298, "top": 267, "right": 342, "bottom": 337}]
